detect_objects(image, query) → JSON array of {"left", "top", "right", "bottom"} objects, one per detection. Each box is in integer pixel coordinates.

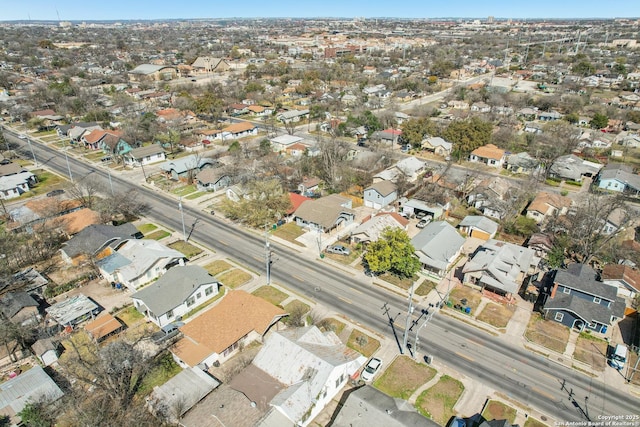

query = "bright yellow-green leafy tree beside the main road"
[{"left": 364, "top": 227, "right": 420, "bottom": 278}]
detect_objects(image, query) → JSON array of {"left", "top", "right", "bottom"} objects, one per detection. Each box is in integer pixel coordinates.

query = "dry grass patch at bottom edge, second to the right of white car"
[{"left": 416, "top": 375, "right": 464, "bottom": 425}]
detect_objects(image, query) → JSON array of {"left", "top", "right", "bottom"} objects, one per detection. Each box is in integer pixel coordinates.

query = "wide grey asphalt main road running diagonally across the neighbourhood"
[{"left": 9, "top": 133, "right": 640, "bottom": 421}]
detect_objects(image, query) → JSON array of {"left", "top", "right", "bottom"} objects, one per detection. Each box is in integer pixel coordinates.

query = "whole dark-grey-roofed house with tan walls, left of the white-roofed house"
[{"left": 60, "top": 223, "right": 142, "bottom": 265}]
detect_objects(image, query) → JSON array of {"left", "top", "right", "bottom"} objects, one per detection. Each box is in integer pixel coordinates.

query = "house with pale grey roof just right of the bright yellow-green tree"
[{"left": 411, "top": 221, "right": 465, "bottom": 277}]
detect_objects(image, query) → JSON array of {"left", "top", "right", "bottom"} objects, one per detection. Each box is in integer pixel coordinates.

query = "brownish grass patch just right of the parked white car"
[{"left": 373, "top": 356, "right": 436, "bottom": 400}]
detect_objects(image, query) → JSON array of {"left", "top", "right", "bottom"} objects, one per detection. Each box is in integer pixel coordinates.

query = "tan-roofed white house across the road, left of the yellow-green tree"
[{"left": 294, "top": 194, "right": 356, "bottom": 233}]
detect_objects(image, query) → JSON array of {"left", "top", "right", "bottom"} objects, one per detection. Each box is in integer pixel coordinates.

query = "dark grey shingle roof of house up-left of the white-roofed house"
[{"left": 62, "top": 223, "right": 138, "bottom": 258}]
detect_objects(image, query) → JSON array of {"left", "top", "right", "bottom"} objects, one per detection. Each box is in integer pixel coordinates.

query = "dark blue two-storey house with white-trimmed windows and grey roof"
[{"left": 543, "top": 264, "right": 625, "bottom": 334}]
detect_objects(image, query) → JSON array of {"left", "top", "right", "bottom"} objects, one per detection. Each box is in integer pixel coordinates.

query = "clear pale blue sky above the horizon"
[{"left": 0, "top": 0, "right": 640, "bottom": 21}]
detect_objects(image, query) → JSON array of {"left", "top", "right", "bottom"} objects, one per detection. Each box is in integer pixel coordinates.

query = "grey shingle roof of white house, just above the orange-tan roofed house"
[{"left": 131, "top": 265, "right": 218, "bottom": 316}]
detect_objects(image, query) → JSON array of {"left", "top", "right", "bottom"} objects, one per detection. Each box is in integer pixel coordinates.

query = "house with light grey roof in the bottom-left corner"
[{"left": 0, "top": 365, "right": 64, "bottom": 426}]
